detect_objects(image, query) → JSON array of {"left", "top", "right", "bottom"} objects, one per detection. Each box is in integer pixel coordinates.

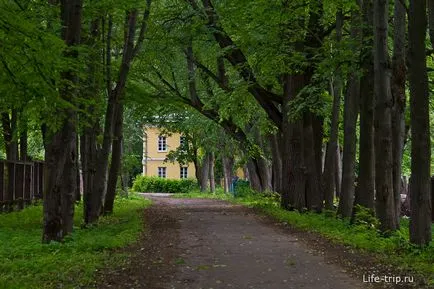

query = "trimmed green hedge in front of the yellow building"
[{"left": 133, "top": 176, "right": 198, "bottom": 194}]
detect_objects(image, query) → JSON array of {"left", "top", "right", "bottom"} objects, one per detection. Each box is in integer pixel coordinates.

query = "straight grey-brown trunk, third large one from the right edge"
[{"left": 374, "top": 0, "right": 397, "bottom": 232}]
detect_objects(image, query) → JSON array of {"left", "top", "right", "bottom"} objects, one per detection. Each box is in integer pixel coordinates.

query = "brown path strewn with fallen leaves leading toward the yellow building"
[{"left": 98, "top": 196, "right": 420, "bottom": 289}]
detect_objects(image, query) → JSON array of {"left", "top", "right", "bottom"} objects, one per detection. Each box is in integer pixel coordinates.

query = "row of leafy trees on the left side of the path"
[{"left": 0, "top": 0, "right": 151, "bottom": 242}]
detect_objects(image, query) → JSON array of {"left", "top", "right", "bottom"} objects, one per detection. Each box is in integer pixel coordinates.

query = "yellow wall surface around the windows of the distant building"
[{"left": 143, "top": 126, "right": 195, "bottom": 179}]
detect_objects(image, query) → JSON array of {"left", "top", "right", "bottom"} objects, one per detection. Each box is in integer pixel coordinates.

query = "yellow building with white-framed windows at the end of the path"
[{"left": 143, "top": 126, "right": 195, "bottom": 179}]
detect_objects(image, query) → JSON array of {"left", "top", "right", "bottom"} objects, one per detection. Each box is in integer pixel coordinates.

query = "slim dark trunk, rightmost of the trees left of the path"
[{"left": 104, "top": 102, "right": 124, "bottom": 214}]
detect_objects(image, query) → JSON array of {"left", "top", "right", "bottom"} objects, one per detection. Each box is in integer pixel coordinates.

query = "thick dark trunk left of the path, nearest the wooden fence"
[{"left": 42, "top": 0, "right": 83, "bottom": 243}]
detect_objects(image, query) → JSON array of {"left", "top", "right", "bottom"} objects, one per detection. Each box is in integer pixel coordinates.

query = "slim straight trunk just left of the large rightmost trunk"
[{"left": 391, "top": 1, "right": 407, "bottom": 227}]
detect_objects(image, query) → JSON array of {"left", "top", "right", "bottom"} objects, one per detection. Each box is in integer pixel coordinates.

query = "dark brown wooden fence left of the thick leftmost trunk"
[{"left": 0, "top": 160, "right": 44, "bottom": 212}]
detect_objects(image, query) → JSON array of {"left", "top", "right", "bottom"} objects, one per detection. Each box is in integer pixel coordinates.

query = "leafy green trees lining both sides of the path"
[{"left": 0, "top": 0, "right": 434, "bottom": 245}]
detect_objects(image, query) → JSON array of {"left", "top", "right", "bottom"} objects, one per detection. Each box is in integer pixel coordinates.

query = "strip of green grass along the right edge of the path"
[{"left": 177, "top": 192, "right": 434, "bottom": 285}]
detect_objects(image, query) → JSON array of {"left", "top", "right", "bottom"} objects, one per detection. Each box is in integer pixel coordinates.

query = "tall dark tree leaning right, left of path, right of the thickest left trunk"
[{"left": 85, "top": 0, "right": 152, "bottom": 223}]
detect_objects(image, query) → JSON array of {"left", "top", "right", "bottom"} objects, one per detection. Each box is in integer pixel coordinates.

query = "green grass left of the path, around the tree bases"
[{"left": 0, "top": 196, "right": 150, "bottom": 289}]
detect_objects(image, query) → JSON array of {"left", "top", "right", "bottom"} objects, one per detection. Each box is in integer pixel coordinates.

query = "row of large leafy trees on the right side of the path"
[{"left": 128, "top": 0, "right": 433, "bottom": 244}]
